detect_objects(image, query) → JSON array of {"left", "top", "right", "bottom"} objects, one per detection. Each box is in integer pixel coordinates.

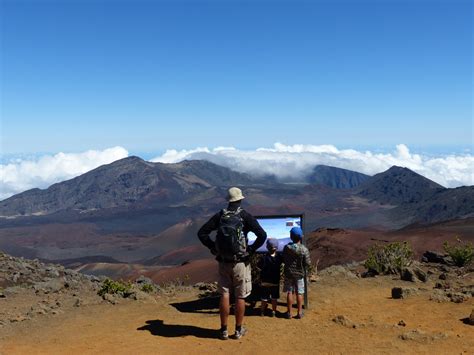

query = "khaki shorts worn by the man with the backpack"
[{"left": 219, "top": 262, "right": 252, "bottom": 298}]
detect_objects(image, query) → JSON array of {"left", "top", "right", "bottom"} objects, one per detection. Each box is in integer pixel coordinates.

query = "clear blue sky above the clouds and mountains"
[{"left": 1, "top": 0, "right": 473, "bottom": 156}]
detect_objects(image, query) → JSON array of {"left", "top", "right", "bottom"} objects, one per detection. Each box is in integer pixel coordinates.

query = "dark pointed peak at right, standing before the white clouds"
[{"left": 358, "top": 166, "right": 445, "bottom": 206}]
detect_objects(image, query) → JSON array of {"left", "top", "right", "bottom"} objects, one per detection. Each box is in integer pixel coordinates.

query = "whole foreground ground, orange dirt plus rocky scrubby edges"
[{"left": 0, "top": 254, "right": 474, "bottom": 354}]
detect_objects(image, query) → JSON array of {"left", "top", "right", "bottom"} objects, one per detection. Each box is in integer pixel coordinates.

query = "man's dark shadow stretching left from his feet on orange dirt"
[{"left": 137, "top": 319, "right": 217, "bottom": 338}]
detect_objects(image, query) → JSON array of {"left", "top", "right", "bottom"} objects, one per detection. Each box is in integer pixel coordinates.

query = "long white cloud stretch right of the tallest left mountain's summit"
[{"left": 151, "top": 143, "right": 474, "bottom": 187}]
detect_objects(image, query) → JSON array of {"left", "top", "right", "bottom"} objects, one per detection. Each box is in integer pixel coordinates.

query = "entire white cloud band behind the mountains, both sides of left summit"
[{"left": 0, "top": 143, "right": 474, "bottom": 200}]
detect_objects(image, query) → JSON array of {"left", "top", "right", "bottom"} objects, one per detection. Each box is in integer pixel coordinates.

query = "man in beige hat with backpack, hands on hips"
[{"left": 198, "top": 187, "right": 267, "bottom": 340}]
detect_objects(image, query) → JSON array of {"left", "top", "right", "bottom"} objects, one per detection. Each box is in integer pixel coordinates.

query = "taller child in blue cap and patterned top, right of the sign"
[{"left": 283, "top": 227, "right": 311, "bottom": 319}]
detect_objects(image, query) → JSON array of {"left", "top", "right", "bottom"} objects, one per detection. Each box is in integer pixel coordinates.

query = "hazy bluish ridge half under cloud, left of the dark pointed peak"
[{"left": 307, "top": 165, "right": 370, "bottom": 189}]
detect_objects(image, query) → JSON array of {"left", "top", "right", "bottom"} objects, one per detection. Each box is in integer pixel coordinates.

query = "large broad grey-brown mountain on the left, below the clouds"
[{"left": 0, "top": 157, "right": 254, "bottom": 216}]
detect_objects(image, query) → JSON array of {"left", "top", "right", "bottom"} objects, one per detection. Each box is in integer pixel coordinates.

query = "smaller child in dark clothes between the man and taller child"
[{"left": 259, "top": 239, "right": 283, "bottom": 317}]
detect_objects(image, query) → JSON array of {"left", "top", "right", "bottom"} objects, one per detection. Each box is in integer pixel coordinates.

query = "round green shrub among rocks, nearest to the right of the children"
[{"left": 364, "top": 242, "right": 413, "bottom": 274}]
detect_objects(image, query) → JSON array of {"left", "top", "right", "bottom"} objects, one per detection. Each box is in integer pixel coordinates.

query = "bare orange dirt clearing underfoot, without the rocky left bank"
[{"left": 0, "top": 277, "right": 474, "bottom": 354}]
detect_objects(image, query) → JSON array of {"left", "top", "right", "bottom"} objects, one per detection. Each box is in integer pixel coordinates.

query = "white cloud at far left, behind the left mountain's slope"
[{"left": 0, "top": 147, "right": 128, "bottom": 199}]
